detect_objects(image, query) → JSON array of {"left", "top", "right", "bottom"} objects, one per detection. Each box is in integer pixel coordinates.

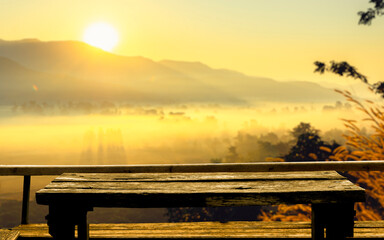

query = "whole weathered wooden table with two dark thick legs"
[{"left": 36, "top": 171, "right": 365, "bottom": 240}]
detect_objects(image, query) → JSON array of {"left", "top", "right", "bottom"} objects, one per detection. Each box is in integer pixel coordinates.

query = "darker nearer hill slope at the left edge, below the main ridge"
[{"left": 0, "top": 57, "right": 152, "bottom": 104}]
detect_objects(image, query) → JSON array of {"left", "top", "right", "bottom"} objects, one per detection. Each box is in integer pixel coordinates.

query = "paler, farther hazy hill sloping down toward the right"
[{"left": 160, "top": 60, "right": 340, "bottom": 103}]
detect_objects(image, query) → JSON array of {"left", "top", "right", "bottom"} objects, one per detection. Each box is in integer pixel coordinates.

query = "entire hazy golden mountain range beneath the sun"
[{"left": 0, "top": 39, "right": 339, "bottom": 104}]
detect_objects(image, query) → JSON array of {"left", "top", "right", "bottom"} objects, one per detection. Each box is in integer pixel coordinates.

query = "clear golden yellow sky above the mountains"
[{"left": 0, "top": 0, "right": 384, "bottom": 82}]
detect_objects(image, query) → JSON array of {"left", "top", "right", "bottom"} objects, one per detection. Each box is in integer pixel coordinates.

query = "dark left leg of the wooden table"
[{"left": 46, "top": 206, "right": 89, "bottom": 240}]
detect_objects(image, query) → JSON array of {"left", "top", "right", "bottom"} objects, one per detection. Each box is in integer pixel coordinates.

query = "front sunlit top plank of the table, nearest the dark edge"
[{"left": 42, "top": 180, "right": 363, "bottom": 194}]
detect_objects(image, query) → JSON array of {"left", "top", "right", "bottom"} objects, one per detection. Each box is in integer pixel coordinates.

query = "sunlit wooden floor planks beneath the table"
[{"left": 13, "top": 222, "right": 310, "bottom": 239}]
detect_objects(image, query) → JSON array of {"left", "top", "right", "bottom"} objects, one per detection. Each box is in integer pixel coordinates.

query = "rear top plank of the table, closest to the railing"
[{"left": 54, "top": 171, "right": 346, "bottom": 182}]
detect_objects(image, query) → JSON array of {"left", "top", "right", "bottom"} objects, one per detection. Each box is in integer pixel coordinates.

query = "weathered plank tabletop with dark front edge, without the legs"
[{"left": 36, "top": 172, "right": 365, "bottom": 208}]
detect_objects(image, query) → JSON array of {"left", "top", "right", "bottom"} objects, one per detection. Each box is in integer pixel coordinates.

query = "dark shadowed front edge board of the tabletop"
[{"left": 36, "top": 189, "right": 365, "bottom": 208}]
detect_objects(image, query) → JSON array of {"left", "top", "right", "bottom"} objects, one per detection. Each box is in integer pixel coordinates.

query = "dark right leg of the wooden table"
[{"left": 312, "top": 203, "right": 355, "bottom": 240}]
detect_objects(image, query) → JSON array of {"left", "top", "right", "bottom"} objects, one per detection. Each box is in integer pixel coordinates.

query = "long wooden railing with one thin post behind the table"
[{"left": 0, "top": 160, "right": 384, "bottom": 224}]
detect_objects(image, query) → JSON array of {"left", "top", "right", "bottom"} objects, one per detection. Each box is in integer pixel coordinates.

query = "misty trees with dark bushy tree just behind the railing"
[{"left": 211, "top": 122, "right": 344, "bottom": 163}]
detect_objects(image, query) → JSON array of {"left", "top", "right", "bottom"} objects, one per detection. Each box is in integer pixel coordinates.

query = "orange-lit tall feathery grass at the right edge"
[{"left": 329, "top": 91, "right": 384, "bottom": 221}]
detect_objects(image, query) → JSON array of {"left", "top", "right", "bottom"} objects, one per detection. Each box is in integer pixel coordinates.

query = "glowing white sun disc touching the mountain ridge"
[{"left": 83, "top": 22, "right": 119, "bottom": 52}]
